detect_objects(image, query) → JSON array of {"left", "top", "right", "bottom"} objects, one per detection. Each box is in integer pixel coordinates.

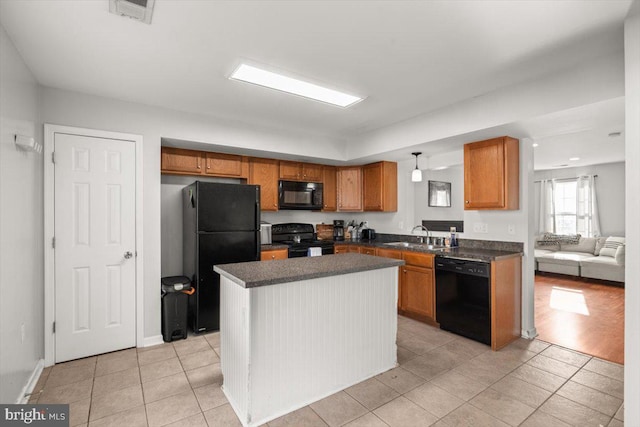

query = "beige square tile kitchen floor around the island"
[{"left": 30, "top": 317, "right": 623, "bottom": 427}]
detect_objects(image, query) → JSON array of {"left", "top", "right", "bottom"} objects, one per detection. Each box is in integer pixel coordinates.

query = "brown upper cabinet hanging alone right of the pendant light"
[{"left": 464, "top": 136, "right": 520, "bottom": 210}]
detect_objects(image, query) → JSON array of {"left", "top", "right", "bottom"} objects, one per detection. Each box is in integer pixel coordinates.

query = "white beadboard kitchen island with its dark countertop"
[{"left": 214, "top": 254, "right": 404, "bottom": 426}]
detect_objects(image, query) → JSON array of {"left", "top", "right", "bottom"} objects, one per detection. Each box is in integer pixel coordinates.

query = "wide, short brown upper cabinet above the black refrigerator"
[{"left": 160, "top": 147, "right": 249, "bottom": 178}]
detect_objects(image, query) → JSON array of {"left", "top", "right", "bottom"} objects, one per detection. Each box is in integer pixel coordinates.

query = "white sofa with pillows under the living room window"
[{"left": 535, "top": 236, "right": 625, "bottom": 282}]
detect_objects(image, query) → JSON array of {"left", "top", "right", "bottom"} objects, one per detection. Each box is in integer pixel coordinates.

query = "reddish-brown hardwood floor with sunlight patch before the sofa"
[{"left": 535, "top": 274, "right": 624, "bottom": 363}]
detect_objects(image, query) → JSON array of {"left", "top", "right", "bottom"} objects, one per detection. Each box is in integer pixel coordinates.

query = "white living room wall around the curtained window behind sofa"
[{"left": 534, "top": 162, "right": 625, "bottom": 236}]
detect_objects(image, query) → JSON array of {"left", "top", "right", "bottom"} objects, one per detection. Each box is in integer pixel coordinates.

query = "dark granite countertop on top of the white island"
[{"left": 213, "top": 254, "right": 404, "bottom": 288}]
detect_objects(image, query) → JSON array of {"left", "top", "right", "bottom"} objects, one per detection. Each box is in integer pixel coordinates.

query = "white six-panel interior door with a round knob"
[{"left": 54, "top": 133, "right": 136, "bottom": 363}]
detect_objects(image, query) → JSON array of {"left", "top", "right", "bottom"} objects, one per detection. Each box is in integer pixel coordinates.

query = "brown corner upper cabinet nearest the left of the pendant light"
[{"left": 362, "top": 162, "right": 398, "bottom": 212}]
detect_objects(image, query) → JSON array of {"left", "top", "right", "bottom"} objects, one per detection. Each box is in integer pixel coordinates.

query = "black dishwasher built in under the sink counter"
[{"left": 436, "top": 256, "right": 491, "bottom": 345}]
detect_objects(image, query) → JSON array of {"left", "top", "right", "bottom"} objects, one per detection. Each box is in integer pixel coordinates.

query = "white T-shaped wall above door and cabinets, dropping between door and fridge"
[{"left": 41, "top": 88, "right": 352, "bottom": 338}]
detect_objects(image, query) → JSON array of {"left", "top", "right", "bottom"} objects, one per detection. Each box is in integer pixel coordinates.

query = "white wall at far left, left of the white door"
[{"left": 0, "top": 26, "right": 44, "bottom": 403}]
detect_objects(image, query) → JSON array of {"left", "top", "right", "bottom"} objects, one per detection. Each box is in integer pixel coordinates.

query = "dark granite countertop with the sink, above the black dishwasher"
[{"left": 335, "top": 240, "right": 523, "bottom": 262}]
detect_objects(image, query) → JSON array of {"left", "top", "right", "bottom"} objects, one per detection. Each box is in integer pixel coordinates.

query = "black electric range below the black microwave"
[{"left": 271, "top": 223, "right": 334, "bottom": 258}]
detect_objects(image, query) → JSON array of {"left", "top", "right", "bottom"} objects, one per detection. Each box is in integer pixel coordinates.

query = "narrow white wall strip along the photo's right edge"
[{"left": 624, "top": 0, "right": 640, "bottom": 426}]
